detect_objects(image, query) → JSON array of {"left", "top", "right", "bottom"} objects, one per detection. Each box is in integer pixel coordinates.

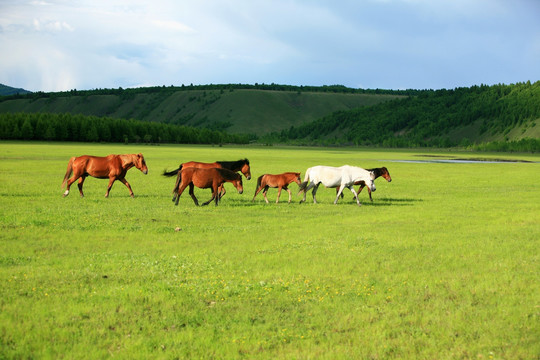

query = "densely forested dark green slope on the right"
[{"left": 266, "top": 82, "right": 540, "bottom": 147}]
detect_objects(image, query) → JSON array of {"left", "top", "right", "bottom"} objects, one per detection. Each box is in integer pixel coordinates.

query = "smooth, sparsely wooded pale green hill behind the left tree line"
[{"left": 0, "top": 84, "right": 402, "bottom": 135}]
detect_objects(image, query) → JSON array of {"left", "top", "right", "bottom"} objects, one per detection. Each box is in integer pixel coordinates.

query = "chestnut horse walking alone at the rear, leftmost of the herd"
[{"left": 62, "top": 154, "right": 148, "bottom": 197}]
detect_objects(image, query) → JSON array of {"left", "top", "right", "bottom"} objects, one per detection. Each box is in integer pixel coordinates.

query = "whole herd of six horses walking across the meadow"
[{"left": 62, "top": 154, "right": 392, "bottom": 206}]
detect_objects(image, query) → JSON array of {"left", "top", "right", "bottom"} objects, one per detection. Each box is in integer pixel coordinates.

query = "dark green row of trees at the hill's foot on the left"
[{"left": 0, "top": 113, "right": 249, "bottom": 144}]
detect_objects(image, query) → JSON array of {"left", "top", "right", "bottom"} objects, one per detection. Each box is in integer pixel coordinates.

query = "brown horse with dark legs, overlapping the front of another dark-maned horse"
[{"left": 173, "top": 167, "right": 244, "bottom": 206}]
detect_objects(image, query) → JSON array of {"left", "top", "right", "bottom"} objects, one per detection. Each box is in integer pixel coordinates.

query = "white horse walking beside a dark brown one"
[{"left": 298, "top": 165, "right": 376, "bottom": 206}]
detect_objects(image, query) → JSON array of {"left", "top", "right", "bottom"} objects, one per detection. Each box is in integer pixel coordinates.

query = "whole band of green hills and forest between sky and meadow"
[{"left": 0, "top": 82, "right": 540, "bottom": 151}]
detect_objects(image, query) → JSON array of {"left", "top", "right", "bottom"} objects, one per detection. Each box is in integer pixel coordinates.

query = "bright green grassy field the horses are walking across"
[{"left": 0, "top": 142, "right": 540, "bottom": 359}]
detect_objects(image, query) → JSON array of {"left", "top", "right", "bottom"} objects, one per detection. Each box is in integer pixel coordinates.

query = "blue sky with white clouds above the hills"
[{"left": 0, "top": 0, "right": 540, "bottom": 92}]
